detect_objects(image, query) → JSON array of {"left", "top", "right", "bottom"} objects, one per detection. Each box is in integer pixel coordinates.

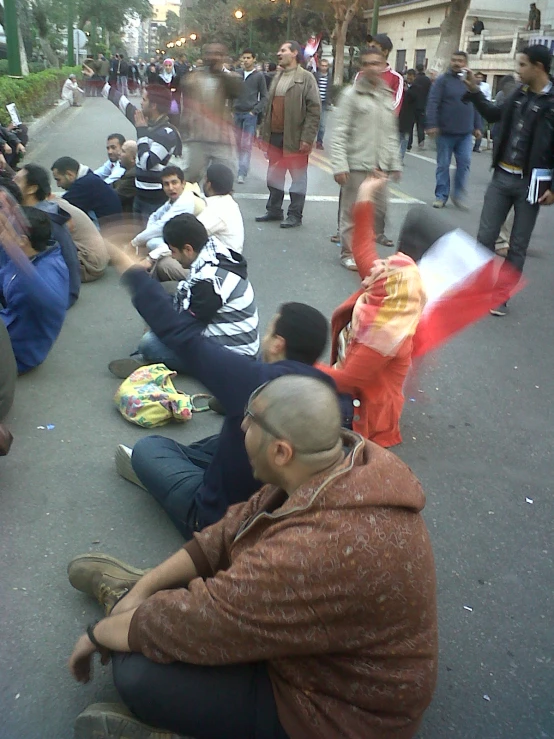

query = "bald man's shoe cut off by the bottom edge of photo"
[{"left": 73, "top": 703, "right": 180, "bottom": 739}]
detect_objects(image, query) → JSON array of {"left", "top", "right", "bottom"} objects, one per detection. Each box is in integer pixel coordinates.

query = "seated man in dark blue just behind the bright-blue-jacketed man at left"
[{"left": 14, "top": 163, "right": 81, "bottom": 308}]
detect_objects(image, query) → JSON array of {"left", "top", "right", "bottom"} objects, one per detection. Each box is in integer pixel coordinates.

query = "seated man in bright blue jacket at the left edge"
[{"left": 0, "top": 206, "right": 69, "bottom": 374}]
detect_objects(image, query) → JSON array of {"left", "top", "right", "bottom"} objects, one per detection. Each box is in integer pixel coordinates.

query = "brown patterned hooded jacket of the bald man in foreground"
[{"left": 129, "top": 431, "right": 438, "bottom": 739}]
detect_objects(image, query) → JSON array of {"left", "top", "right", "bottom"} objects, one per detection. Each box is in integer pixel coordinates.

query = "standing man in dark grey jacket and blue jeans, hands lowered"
[{"left": 235, "top": 49, "right": 267, "bottom": 185}]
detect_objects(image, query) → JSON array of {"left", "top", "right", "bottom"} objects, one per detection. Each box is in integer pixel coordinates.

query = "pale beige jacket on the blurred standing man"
[{"left": 331, "top": 75, "right": 402, "bottom": 174}]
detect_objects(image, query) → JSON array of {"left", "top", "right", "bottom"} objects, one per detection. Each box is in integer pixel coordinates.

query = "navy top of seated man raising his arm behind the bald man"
[{"left": 122, "top": 268, "right": 344, "bottom": 528}]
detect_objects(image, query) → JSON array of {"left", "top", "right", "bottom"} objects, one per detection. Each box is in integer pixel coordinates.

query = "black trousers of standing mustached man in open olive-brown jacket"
[{"left": 266, "top": 133, "right": 308, "bottom": 221}]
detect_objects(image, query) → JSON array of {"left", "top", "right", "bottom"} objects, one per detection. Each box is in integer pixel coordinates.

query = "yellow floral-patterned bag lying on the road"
[{"left": 114, "top": 364, "right": 210, "bottom": 429}]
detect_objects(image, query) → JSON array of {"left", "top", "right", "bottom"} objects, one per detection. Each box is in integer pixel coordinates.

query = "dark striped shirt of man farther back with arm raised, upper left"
[{"left": 102, "top": 83, "right": 183, "bottom": 203}]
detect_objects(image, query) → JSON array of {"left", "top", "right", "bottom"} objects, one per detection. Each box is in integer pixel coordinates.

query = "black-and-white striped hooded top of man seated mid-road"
[{"left": 175, "top": 238, "right": 260, "bottom": 357}]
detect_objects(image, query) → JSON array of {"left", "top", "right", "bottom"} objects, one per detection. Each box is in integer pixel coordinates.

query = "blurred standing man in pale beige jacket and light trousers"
[{"left": 331, "top": 46, "right": 402, "bottom": 271}]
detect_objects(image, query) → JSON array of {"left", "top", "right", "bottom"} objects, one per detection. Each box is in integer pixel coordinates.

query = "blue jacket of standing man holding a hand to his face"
[{"left": 425, "top": 70, "right": 482, "bottom": 136}]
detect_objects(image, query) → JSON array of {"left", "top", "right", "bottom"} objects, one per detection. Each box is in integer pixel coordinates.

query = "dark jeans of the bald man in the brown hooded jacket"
[{"left": 113, "top": 653, "right": 288, "bottom": 739}]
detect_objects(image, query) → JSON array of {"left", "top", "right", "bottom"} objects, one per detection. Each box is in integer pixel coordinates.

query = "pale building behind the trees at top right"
[{"left": 367, "top": 0, "right": 554, "bottom": 91}]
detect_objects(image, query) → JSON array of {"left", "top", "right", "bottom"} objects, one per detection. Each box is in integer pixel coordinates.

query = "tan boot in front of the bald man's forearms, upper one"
[{"left": 67, "top": 553, "right": 147, "bottom": 616}]
